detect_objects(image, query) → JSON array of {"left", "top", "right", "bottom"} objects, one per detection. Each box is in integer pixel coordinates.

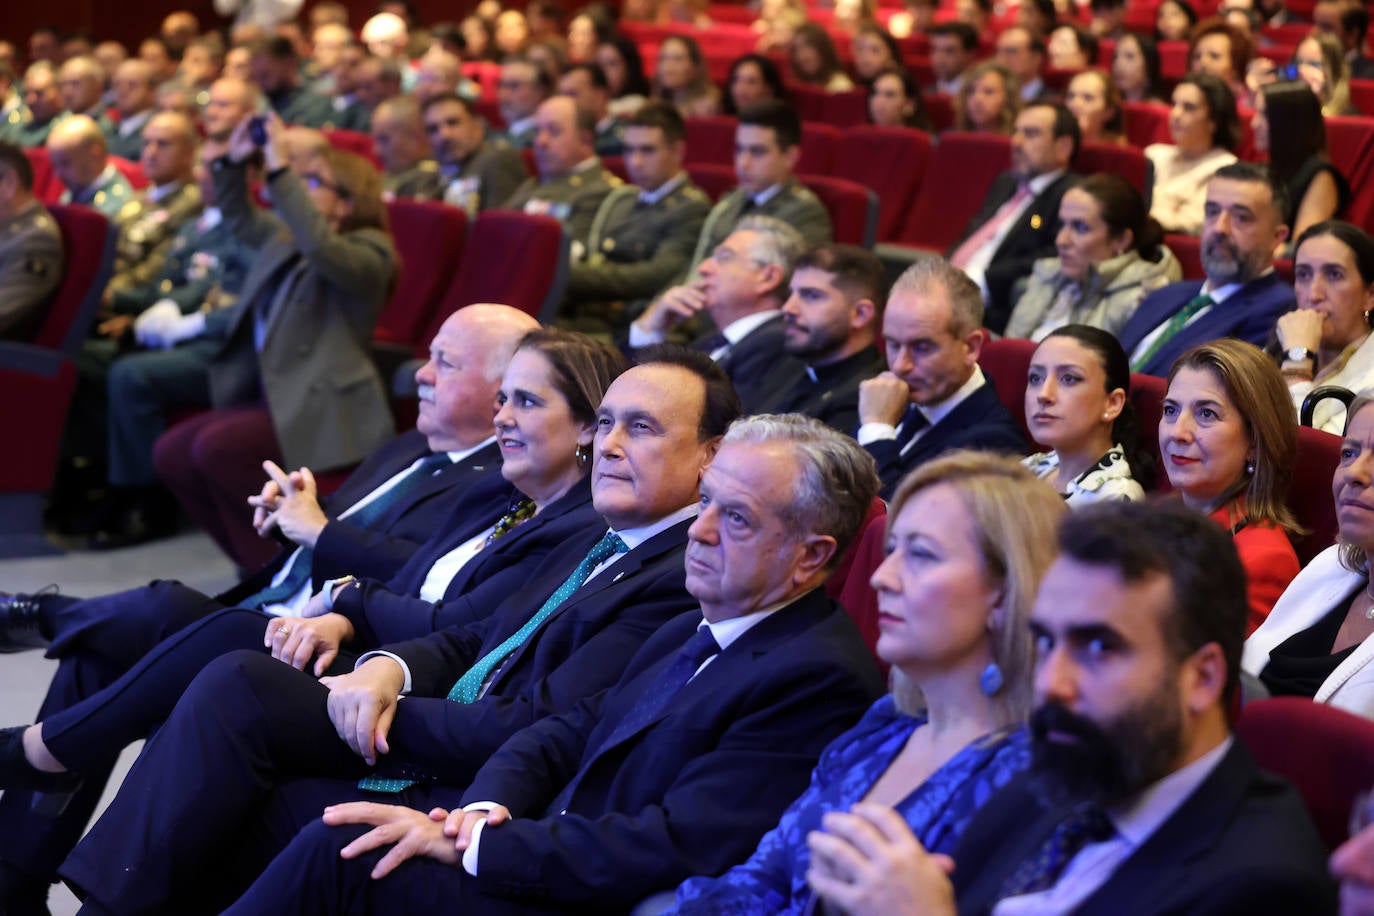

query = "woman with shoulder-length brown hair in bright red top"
[{"left": 1160, "top": 338, "right": 1298, "bottom": 636}]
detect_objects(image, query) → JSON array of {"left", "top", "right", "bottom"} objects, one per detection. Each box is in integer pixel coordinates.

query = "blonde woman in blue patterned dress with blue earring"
[{"left": 668, "top": 452, "right": 1065, "bottom": 916}]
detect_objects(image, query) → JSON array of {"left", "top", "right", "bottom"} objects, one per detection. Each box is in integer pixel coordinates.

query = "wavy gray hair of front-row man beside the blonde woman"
[{"left": 721, "top": 414, "right": 879, "bottom": 570}]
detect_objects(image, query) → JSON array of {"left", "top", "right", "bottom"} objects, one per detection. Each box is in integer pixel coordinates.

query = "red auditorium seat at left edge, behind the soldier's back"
[{"left": 0, "top": 206, "right": 115, "bottom": 556}]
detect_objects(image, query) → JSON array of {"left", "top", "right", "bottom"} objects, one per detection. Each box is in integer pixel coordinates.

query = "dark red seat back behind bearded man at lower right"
[{"left": 1235, "top": 696, "right": 1374, "bottom": 849}]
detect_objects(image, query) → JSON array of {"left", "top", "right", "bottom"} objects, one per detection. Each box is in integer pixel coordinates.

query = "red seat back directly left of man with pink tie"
[{"left": 901, "top": 130, "right": 1011, "bottom": 251}]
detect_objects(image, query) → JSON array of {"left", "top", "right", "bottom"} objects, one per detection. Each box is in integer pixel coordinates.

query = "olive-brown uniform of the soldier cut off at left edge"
[{"left": 0, "top": 201, "right": 63, "bottom": 338}]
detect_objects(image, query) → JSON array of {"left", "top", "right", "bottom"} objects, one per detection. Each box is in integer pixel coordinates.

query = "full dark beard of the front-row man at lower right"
[{"left": 1029, "top": 681, "right": 1183, "bottom": 808}]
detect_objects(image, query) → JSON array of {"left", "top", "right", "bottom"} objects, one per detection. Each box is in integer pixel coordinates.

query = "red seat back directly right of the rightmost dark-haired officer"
[{"left": 831, "top": 124, "right": 930, "bottom": 242}]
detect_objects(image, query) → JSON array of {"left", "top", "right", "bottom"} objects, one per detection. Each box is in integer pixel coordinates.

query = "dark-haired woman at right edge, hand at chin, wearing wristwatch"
[{"left": 1274, "top": 220, "right": 1374, "bottom": 435}]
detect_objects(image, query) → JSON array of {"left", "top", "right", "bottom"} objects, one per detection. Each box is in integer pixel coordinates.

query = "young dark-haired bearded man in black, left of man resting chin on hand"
[{"left": 758, "top": 244, "right": 888, "bottom": 434}]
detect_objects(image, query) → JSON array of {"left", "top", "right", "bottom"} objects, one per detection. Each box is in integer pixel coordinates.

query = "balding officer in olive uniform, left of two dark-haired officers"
[{"left": 504, "top": 96, "right": 622, "bottom": 258}]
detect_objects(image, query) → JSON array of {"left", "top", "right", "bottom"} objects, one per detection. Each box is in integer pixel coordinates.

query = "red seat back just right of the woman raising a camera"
[{"left": 372, "top": 201, "right": 467, "bottom": 346}]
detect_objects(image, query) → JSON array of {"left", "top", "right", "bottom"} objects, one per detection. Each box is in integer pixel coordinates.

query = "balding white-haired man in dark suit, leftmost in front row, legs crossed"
[{"left": 0, "top": 305, "right": 539, "bottom": 909}]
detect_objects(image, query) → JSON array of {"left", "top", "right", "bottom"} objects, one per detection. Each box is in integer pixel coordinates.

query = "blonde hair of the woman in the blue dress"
[{"left": 888, "top": 450, "right": 1066, "bottom": 722}]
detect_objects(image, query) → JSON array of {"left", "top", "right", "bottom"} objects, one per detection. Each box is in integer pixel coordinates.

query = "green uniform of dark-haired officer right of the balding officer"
[{"left": 567, "top": 174, "right": 710, "bottom": 325}]
